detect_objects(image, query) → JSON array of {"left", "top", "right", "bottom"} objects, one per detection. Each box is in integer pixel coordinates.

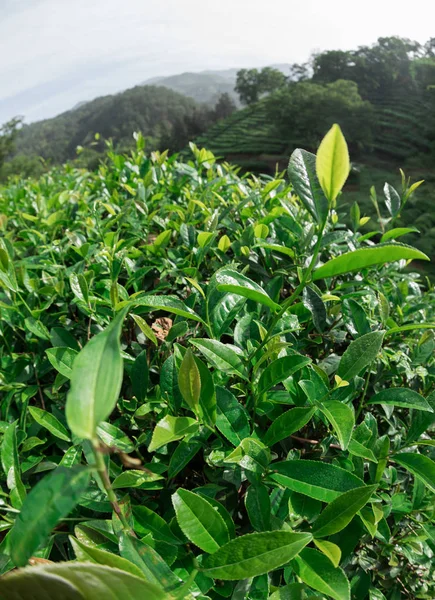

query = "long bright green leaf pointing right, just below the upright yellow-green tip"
[{"left": 313, "top": 242, "right": 430, "bottom": 281}]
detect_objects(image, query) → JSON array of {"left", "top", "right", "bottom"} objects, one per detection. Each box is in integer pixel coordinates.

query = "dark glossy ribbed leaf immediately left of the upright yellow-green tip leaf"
[{"left": 288, "top": 148, "right": 328, "bottom": 223}]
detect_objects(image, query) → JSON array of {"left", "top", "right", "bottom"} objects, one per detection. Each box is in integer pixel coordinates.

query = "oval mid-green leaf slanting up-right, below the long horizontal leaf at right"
[{"left": 337, "top": 331, "right": 385, "bottom": 381}]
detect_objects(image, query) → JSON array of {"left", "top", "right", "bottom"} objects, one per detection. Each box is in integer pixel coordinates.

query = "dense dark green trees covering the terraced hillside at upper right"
[{"left": 236, "top": 37, "right": 435, "bottom": 159}]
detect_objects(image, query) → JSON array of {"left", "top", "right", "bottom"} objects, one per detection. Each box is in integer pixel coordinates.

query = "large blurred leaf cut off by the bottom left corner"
[{"left": 0, "top": 563, "right": 167, "bottom": 600}]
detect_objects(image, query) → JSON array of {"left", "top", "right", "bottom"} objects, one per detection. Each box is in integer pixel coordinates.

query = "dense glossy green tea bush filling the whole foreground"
[{"left": 0, "top": 126, "right": 435, "bottom": 600}]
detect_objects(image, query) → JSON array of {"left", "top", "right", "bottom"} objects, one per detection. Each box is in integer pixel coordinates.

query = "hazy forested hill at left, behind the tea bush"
[{"left": 0, "top": 86, "right": 236, "bottom": 179}]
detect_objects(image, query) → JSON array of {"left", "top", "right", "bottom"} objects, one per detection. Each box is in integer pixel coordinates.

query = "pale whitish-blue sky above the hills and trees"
[{"left": 0, "top": 0, "right": 435, "bottom": 124}]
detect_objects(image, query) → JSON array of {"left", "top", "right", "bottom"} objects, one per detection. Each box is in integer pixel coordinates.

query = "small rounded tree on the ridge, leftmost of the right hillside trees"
[{"left": 235, "top": 67, "right": 287, "bottom": 104}]
